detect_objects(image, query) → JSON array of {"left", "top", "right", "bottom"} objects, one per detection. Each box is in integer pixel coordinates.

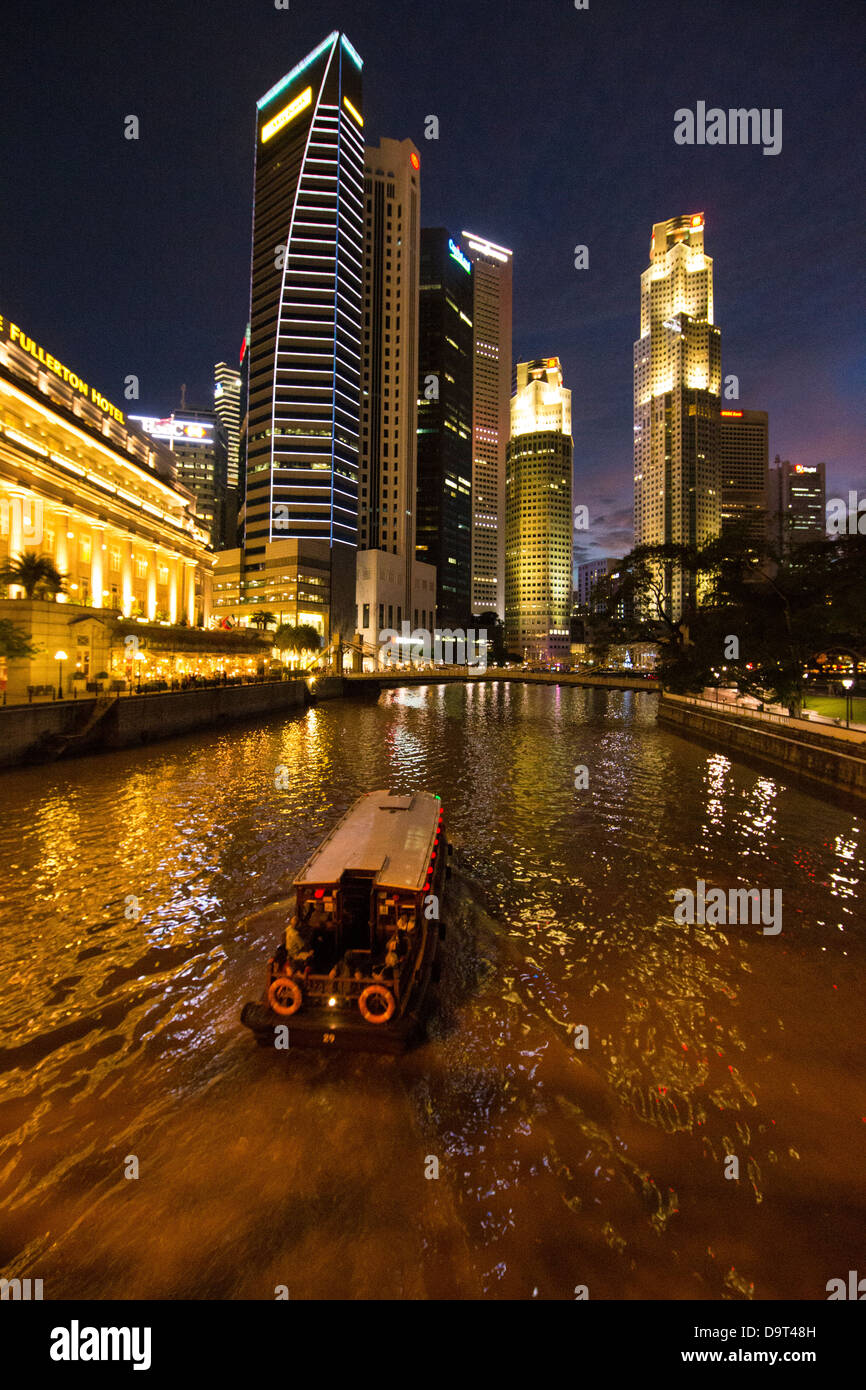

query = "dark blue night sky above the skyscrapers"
[{"left": 0, "top": 0, "right": 866, "bottom": 559}]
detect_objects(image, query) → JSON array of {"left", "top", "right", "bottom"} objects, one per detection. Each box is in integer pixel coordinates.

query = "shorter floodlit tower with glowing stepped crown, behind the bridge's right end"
[{"left": 505, "top": 357, "right": 573, "bottom": 664}]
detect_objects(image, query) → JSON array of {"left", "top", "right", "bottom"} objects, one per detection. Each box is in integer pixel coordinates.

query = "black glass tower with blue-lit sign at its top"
[{"left": 416, "top": 227, "right": 473, "bottom": 626}]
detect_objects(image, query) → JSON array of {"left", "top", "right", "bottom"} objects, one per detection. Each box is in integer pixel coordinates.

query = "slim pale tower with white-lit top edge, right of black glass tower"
[{"left": 461, "top": 232, "right": 513, "bottom": 619}]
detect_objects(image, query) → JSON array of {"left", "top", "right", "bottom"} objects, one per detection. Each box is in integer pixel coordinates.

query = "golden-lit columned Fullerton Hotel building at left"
[{"left": 0, "top": 316, "right": 213, "bottom": 700}]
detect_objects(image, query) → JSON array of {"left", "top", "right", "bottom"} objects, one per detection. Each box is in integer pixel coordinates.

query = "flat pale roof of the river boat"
[{"left": 295, "top": 791, "right": 442, "bottom": 892}]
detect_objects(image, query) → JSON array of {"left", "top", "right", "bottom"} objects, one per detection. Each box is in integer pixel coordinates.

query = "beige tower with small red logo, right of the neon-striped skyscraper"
[{"left": 356, "top": 139, "right": 435, "bottom": 646}]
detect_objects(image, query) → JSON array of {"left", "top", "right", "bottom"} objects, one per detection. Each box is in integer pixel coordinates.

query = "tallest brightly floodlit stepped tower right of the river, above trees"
[{"left": 634, "top": 213, "right": 721, "bottom": 619}]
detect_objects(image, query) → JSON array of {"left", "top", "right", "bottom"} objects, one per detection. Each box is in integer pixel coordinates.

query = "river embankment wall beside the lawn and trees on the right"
[{"left": 657, "top": 695, "right": 866, "bottom": 805}]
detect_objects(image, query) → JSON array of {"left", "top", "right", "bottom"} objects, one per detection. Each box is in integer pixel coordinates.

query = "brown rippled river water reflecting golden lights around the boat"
[{"left": 0, "top": 684, "right": 866, "bottom": 1300}]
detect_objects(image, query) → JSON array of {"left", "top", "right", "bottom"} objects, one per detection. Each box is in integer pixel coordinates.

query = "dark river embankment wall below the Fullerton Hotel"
[{"left": 0, "top": 680, "right": 309, "bottom": 767}]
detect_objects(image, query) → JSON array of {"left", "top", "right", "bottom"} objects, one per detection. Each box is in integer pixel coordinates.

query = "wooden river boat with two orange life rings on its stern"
[{"left": 240, "top": 791, "right": 452, "bottom": 1052}]
